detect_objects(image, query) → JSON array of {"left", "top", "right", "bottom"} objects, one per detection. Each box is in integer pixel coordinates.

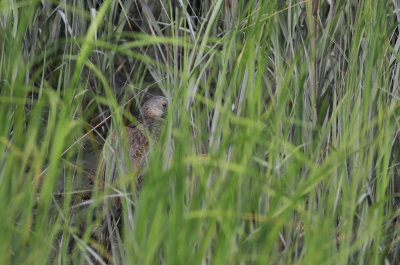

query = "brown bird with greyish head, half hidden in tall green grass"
[{"left": 97, "top": 96, "right": 168, "bottom": 258}]
